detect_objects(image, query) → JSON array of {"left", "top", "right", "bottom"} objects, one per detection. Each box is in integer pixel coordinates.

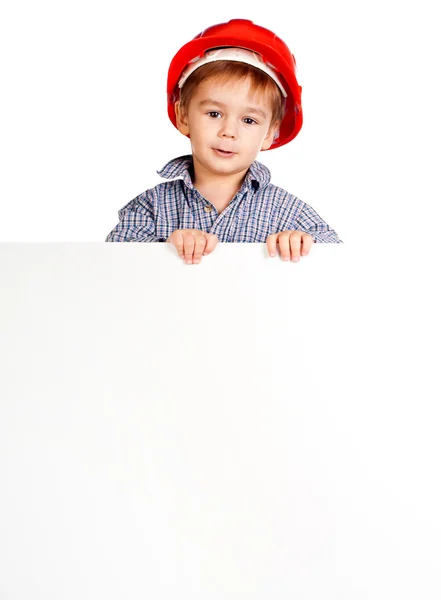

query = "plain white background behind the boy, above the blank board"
[{"left": 0, "top": 0, "right": 441, "bottom": 244}]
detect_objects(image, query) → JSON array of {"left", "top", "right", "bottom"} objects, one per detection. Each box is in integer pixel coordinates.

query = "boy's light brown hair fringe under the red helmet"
[{"left": 180, "top": 60, "right": 285, "bottom": 128}]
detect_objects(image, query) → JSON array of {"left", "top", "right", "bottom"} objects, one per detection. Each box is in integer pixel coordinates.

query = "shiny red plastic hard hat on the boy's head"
[{"left": 167, "top": 19, "right": 303, "bottom": 149}]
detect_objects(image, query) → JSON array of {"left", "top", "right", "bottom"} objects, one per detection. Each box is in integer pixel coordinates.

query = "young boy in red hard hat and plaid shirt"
[{"left": 106, "top": 19, "right": 340, "bottom": 264}]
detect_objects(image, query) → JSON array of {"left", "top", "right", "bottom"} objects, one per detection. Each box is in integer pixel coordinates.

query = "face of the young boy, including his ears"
[{"left": 177, "top": 74, "right": 275, "bottom": 175}]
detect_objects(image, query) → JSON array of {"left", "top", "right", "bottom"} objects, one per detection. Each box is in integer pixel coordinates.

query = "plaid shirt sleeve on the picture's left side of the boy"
[{"left": 106, "top": 191, "right": 166, "bottom": 242}]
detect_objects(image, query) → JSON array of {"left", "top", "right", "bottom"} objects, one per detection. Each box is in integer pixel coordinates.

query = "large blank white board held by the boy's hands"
[{"left": 0, "top": 243, "right": 441, "bottom": 600}]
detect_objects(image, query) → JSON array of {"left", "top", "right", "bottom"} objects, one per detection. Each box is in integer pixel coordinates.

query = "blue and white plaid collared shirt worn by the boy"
[{"left": 106, "top": 155, "right": 341, "bottom": 243}]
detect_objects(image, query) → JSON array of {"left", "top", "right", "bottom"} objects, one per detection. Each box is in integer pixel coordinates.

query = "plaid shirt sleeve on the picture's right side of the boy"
[{"left": 279, "top": 196, "right": 343, "bottom": 244}]
